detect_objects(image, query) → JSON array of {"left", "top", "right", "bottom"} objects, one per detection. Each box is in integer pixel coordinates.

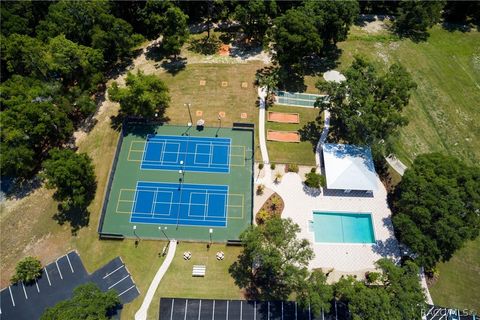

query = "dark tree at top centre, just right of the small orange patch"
[{"left": 234, "top": 0, "right": 278, "bottom": 41}]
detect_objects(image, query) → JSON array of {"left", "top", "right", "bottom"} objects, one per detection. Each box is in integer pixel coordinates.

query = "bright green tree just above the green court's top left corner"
[{"left": 108, "top": 70, "right": 170, "bottom": 120}]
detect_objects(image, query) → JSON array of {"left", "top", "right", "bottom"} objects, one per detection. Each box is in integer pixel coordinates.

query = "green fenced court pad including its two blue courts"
[{"left": 99, "top": 123, "right": 253, "bottom": 242}]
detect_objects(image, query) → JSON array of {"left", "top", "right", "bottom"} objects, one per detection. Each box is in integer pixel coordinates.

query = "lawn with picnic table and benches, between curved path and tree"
[{"left": 148, "top": 242, "right": 244, "bottom": 320}]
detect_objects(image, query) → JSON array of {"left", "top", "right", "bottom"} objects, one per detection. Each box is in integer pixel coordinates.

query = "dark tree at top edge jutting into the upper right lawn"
[{"left": 394, "top": 0, "right": 446, "bottom": 41}]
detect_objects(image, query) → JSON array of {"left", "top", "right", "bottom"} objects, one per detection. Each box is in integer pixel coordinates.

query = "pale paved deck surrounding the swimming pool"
[{"left": 255, "top": 168, "right": 399, "bottom": 281}]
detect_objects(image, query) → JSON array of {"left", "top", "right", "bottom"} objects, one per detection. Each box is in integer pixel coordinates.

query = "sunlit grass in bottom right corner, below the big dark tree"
[{"left": 429, "top": 237, "right": 480, "bottom": 314}]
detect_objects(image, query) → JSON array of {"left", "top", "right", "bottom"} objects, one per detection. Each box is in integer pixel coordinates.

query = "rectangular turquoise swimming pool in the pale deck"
[{"left": 309, "top": 212, "right": 375, "bottom": 243}]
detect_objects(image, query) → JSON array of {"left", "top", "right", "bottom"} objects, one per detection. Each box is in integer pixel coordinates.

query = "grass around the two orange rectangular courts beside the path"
[{"left": 265, "top": 105, "right": 319, "bottom": 165}]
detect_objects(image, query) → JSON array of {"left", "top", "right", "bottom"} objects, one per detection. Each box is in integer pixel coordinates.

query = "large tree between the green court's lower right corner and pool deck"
[{"left": 229, "top": 218, "right": 313, "bottom": 300}]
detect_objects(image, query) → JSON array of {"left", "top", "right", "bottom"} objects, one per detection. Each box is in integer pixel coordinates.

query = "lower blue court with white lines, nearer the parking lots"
[{"left": 130, "top": 181, "right": 228, "bottom": 227}]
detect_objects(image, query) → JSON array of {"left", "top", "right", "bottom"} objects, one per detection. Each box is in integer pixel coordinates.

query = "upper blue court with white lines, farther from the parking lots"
[{"left": 140, "top": 135, "right": 231, "bottom": 173}]
